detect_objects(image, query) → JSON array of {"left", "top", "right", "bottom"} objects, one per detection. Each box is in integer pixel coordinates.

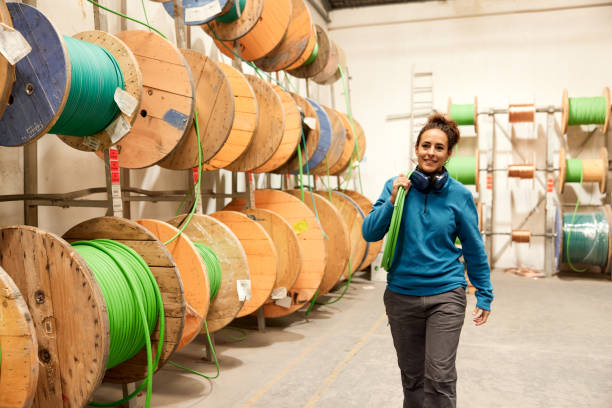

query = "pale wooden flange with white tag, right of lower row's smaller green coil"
[{"left": 168, "top": 214, "right": 249, "bottom": 333}]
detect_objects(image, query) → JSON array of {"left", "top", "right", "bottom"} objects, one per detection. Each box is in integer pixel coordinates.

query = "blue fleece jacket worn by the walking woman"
[{"left": 362, "top": 177, "right": 493, "bottom": 310}]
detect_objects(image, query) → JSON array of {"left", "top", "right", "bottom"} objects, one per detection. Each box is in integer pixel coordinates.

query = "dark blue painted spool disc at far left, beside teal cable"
[{"left": 0, "top": 3, "right": 70, "bottom": 146}]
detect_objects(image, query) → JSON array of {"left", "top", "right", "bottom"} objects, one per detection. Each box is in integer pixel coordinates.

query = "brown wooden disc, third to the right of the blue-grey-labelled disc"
[{"left": 225, "top": 75, "right": 285, "bottom": 171}]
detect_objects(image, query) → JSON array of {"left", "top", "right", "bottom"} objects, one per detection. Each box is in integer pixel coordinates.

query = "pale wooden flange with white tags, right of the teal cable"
[{"left": 58, "top": 30, "right": 142, "bottom": 152}]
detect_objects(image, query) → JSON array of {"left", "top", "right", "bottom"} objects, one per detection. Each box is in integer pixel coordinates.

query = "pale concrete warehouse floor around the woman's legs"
[{"left": 95, "top": 271, "right": 612, "bottom": 408}]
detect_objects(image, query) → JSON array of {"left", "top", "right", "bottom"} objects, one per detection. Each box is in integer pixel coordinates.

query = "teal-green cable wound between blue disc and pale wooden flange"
[{"left": 49, "top": 36, "right": 125, "bottom": 136}]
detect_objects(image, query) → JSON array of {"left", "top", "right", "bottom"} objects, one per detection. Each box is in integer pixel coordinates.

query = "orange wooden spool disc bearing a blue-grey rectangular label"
[{"left": 97, "top": 30, "right": 195, "bottom": 169}]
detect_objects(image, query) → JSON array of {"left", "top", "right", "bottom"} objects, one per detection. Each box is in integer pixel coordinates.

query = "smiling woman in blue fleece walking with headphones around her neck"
[{"left": 362, "top": 114, "right": 493, "bottom": 408}]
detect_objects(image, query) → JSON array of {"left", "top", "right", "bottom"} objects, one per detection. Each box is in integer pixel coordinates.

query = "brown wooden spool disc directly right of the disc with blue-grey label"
[{"left": 159, "top": 49, "right": 235, "bottom": 170}]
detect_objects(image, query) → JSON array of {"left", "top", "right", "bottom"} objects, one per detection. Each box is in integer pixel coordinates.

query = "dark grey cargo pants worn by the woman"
[{"left": 384, "top": 287, "right": 466, "bottom": 408}]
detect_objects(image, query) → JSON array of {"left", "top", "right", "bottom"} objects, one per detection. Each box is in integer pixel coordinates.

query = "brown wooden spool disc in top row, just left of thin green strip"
[{"left": 255, "top": 0, "right": 314, "bottom": 72}]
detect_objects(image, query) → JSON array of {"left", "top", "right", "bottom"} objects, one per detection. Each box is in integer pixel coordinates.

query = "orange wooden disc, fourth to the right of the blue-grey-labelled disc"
[{"left": 253, "top": 84, "right": 302, "bottom": 173}]
